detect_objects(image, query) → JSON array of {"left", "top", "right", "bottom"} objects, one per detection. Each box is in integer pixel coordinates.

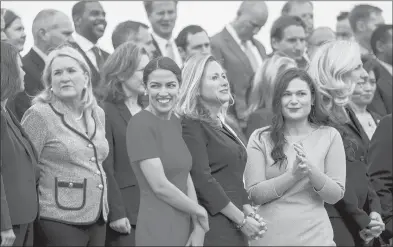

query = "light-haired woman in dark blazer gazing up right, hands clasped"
[{"left": 176, "top": 54, "right": 266, "bottom": 246}]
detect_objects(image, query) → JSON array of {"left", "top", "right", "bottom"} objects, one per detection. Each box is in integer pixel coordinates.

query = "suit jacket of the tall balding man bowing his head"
[{"left": 211, "top": 28, "right": 267, "bottom": 137}]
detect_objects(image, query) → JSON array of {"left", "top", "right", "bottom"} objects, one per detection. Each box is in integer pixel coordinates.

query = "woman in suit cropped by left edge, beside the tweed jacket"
[{"left": 0, "top": 41, "right": 38, "bottom": 246}]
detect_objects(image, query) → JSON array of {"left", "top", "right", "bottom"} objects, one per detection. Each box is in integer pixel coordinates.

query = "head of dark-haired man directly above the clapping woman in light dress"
[{"left": 270, "top": 16, "right": 309, "bottom": 68}]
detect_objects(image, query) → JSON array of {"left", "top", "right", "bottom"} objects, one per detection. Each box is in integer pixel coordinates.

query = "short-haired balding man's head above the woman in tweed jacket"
[{"left": 32, "top": 9, "right": 74, "bottom": 52}]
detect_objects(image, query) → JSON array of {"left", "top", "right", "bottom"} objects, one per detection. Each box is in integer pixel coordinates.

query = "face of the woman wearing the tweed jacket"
[{"left": 51, "top": 57, "right": 89, "bottom": 100}]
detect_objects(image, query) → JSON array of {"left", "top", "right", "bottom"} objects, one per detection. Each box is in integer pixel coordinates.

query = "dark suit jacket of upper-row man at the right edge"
[{"left": 368, "top": 62, "right": 393, "bottom": 116}]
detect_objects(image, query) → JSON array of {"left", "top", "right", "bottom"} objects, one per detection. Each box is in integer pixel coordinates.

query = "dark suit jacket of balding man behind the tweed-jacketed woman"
[{"left": 8, "top": 49, "right": 45, "bottom": 121}]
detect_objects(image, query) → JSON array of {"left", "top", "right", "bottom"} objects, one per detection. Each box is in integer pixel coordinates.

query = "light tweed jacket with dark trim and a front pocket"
[{"left": 22, "top": 101, "right": 109, "bottom": 225}]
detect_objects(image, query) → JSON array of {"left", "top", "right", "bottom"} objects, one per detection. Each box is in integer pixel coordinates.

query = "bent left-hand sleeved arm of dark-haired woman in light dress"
[{"left": 243, "top": 130, "right": 298, "bottom": 204}]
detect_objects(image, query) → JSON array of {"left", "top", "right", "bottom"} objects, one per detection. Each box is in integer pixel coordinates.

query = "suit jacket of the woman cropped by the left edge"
[{"left": 0, "top": 109, "right": 38, "bottom": 231}]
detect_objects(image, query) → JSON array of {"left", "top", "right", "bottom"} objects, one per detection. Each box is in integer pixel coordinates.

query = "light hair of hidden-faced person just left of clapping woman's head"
[{"left": 246, "top": 55, "right": 297, "bottom": 115}]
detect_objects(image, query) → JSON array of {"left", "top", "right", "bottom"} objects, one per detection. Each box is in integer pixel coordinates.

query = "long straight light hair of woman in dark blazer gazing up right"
[{"left": 175, "top": 54, "right": 234, "bottom": 125}]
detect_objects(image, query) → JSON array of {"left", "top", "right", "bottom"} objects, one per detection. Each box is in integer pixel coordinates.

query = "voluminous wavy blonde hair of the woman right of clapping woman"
[{"left": 308, "top": 40, "right": 361, "bottom": 123}]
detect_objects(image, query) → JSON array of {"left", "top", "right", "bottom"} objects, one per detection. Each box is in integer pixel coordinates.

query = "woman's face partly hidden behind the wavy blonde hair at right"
[{"left": 351, "top": 71, "right": 377, "bottom": 106}]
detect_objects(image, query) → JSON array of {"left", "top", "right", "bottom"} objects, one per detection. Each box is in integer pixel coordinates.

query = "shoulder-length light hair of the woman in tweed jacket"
[{"left": 33, "top": 45, "right": 97, "bottom": 109}]
